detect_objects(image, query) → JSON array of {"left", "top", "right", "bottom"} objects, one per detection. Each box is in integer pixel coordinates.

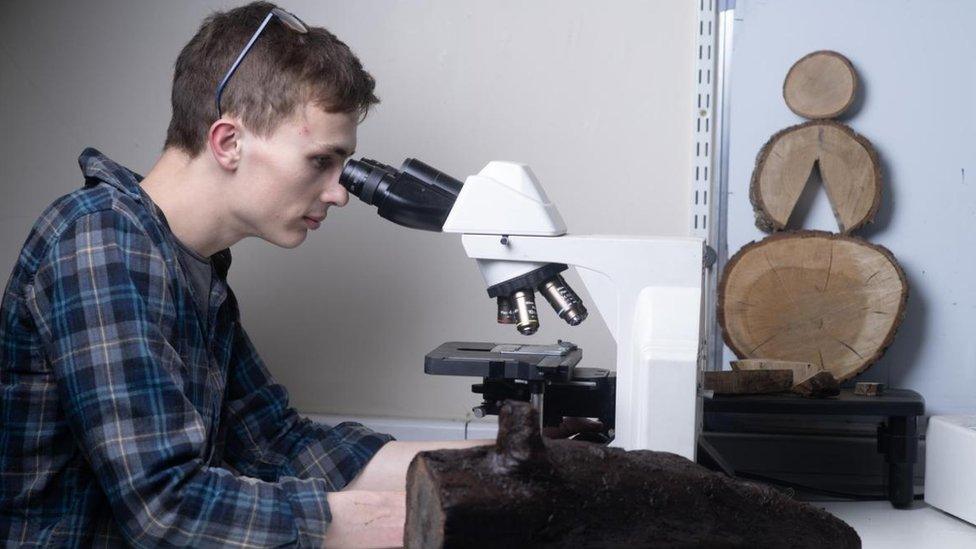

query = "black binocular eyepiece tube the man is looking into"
[{"left": 339, "top": 158, "right": 464, "bottom": 231}]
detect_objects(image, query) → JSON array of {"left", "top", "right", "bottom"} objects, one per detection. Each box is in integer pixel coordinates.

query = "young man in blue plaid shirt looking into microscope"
[{"left": 0, "top": 2, "right": 486, "bottom": 547}]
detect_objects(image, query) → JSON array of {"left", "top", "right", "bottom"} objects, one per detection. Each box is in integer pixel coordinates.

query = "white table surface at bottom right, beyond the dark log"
[{"left": 810, "top": 501, "right": 976, "bottom": 549}]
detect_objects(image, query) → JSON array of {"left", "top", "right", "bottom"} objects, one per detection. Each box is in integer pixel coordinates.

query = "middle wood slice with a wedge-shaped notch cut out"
[{"left": 749, "top": 120, "right": 882, "bottom": 233}]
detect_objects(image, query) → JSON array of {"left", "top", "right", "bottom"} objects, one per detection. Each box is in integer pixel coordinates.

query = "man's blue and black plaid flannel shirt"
[{"left": 0, "top": 149, "right": 392, "bottom": 547}]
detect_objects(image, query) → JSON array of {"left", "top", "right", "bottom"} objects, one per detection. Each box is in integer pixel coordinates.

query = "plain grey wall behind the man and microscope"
[{"left": 0, "top": 0, "right": 696, "bottom": 418}]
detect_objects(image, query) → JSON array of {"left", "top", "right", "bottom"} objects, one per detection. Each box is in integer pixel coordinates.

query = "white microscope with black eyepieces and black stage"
[{"left": 340, "top": 159, "right": 705, "bottom": 460}]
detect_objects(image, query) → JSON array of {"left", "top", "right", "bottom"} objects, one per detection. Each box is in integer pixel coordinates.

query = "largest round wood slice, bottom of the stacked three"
[{"left": 718, "top": 231, "right": 908, "bottom": 381}]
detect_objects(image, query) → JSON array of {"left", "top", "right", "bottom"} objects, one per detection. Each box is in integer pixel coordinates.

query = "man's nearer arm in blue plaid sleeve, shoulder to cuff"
[{"left": 27, "top": 211, "right": 331, "bottom": 547}]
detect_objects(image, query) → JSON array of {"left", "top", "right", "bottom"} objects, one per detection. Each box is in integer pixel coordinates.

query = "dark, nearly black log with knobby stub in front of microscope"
[{"left": 404, "top": 401, "right": 860, "bottom": 549}]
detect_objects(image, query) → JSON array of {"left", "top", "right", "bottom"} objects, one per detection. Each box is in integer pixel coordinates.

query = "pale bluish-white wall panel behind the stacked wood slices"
[{"left": 727, "top": 0, "right": 976, "bottom": 414}]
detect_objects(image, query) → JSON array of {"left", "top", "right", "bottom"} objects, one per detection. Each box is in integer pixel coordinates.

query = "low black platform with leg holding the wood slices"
[{"left": 703, "top": 389, "right": 925, "bottom": 509}]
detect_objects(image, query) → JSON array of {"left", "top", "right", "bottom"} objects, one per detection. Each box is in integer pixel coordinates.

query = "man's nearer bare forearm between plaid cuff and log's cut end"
[{"left": 324, "top": 490, "right": 407, "bottom": 548}]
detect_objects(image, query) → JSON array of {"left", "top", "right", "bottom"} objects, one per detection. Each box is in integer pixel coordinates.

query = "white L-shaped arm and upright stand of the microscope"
[{"left": 461, "top": 234, "right": 704, "bottom": 458}]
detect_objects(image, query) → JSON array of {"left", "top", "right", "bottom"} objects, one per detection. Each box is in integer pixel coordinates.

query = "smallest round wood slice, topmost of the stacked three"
[{"left": 783, "top": 50, "right": 857, "bottom": 119}]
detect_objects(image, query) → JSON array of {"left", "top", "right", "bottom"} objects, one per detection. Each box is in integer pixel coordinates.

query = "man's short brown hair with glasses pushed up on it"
[{"left": 165, "top": 2, "right": 379, "bottom": 156}]
